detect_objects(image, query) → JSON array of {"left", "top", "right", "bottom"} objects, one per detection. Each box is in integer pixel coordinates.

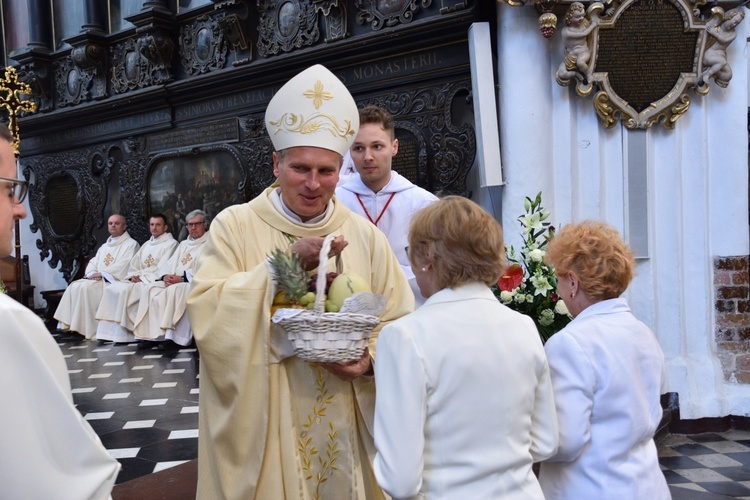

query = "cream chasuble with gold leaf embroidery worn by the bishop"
[{"left": 188, "top": 188, "right": 414, "bottom": 499}]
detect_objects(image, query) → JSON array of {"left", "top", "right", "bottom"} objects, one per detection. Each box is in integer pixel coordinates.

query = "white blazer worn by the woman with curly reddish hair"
[{"left": 539, "top": 298, "right": 671, "bottom": 500}]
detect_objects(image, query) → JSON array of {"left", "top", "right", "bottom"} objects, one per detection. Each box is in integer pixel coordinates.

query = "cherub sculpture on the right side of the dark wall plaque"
[{"left": 698, "top": 7, "right": 745, "bottom": 93}]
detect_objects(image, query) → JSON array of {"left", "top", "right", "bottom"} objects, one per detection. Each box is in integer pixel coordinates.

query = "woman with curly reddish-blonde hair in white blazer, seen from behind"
[{"left": 539, "top": 221, "right": 670, "bottom": 500}]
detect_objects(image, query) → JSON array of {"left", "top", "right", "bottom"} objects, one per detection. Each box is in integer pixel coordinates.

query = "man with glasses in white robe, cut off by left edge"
[{"left": 0, "top": 125, "right": 120, "bottom": 498}]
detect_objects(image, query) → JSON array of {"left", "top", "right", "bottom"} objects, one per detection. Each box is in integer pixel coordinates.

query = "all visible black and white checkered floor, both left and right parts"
[{"left": 53, "top": 328, "right": 750, "bottom": 492}]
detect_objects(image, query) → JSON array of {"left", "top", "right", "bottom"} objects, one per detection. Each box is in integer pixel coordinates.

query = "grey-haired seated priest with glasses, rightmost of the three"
[{"left": 133, "top": 210, "right": 208, "bottom": 350}]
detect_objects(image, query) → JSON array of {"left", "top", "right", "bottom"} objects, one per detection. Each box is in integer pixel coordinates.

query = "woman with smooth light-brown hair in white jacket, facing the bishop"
[{"left": 374, "top": 196, "right": 557, "bottom": 500}]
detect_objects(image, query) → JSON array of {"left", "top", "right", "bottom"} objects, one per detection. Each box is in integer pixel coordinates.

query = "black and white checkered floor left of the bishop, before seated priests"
[{"left": 53, "top": 334, "right": 198, "bottom": 484}]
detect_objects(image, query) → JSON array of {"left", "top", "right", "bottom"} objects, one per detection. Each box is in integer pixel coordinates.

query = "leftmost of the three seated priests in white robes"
[{"left": 54, "top": 214, "right": 138, "bottom": 340}]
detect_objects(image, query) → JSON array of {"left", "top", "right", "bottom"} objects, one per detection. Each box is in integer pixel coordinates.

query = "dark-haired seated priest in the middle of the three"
[{"left": 96, "top": 214, "right": 177, "bottom": 343}]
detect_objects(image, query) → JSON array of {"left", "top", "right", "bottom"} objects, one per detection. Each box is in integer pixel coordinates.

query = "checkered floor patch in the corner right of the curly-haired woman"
[{"left": 658, "top": 430, "right": 750, "bottom": 499}]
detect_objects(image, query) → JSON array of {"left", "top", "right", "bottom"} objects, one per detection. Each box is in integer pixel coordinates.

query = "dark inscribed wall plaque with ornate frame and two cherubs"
[{"left": 555, "top": 0, "right": 744, "bottom": 129}]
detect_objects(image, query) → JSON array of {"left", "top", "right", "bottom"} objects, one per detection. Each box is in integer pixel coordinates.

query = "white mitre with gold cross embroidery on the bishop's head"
[{"left": 266, "top": 64, "right": 359, "bottom": 156}]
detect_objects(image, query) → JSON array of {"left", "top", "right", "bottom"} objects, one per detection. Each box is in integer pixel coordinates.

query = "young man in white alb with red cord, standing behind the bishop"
[{"left": 336, "top": 106, "right": 437, "bottom": 307}]
